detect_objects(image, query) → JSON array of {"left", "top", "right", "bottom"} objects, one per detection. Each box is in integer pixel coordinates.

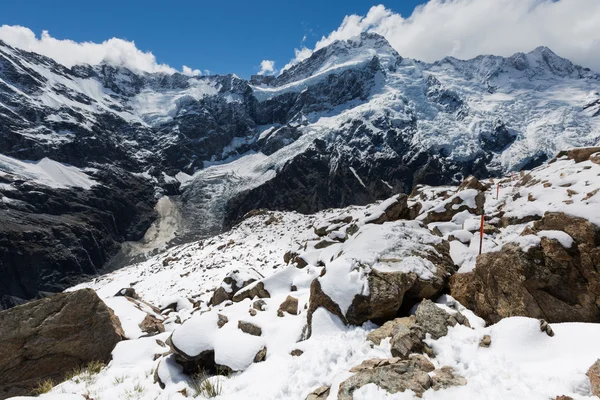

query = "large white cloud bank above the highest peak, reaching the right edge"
[{"left": 288, "top": 0, "right": 600, "bottom": 72}]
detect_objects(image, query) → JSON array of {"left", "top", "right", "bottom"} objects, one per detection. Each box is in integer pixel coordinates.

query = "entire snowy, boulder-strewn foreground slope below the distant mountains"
[{"left": 0, "top": 148, "right": 600, "bottom": 400}]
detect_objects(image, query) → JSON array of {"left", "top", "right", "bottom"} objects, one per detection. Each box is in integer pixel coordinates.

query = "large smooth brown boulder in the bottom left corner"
[{"left": 0, "top": 289, "right": 125, "bottom": 399}]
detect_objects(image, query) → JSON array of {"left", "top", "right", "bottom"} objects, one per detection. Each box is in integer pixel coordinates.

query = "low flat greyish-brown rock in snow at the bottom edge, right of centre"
[{"left": 338, "top": 355, "right": 467, "bottom": 400}]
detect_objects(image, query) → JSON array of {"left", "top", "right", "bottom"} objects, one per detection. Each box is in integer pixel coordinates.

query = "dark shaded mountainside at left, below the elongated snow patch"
[{"left": 0, "top": 169, "right": 156, "bottom": 309}]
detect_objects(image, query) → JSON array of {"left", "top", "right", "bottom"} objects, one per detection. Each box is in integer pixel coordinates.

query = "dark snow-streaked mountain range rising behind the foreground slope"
[{"left": 0, "top": 34, "right": 600, "bottom": 306}]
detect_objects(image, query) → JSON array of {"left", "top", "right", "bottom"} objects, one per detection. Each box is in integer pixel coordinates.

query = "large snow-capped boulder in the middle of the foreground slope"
[{"left": 308, "top": 221, "right": 454, "bottom": 332}]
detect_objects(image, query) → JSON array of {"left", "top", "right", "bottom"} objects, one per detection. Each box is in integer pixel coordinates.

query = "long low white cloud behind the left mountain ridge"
[{"left": 0, "top": 25, "right": 200, "bottom": 75}]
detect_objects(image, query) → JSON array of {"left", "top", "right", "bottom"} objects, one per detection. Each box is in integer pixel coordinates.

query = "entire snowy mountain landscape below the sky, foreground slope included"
[{"left": 0, "top": 33, "right": 600, "bottom": 400}]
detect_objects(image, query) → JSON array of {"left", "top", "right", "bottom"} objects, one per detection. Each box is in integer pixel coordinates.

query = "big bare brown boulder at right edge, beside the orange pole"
[{"left": 450, "top": 213, "right": 600, "bottom": 323}]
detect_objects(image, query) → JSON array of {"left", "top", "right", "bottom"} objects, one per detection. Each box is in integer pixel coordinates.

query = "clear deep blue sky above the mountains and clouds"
[{"left": 0, "top": 0, "right": 423, "bottom": 78}]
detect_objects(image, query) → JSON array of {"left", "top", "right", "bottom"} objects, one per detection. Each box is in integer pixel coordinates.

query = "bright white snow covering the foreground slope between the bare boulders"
[{"left": 34, "top": 149, "right": 600, "bottom": 400}]
